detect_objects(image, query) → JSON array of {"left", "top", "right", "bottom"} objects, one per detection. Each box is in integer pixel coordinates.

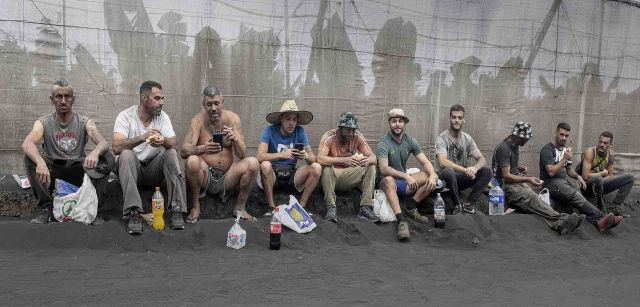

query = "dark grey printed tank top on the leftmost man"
[{"left": 38, "top": 113, "right": 89, "bottom": 160}]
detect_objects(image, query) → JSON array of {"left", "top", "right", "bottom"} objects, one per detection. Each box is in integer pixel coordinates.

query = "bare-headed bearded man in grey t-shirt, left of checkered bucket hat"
[{"left": 436, "top": 104, "right": 491, "bottom": 214}]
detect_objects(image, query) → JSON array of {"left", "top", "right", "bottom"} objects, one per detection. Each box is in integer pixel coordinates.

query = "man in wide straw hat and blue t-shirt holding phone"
[{"left": 256, "top": 100, "right": 321, "bottom": 213}]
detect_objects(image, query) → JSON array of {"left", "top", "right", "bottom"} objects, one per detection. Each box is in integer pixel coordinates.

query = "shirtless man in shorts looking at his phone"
[{"left": 181, "top": 86, "right": 259, "bottom": 223}]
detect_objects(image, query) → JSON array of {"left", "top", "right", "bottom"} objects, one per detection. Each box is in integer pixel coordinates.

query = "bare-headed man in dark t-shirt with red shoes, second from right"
[{"left": 538, "top": 123, "right": 622, "bottom": 233}]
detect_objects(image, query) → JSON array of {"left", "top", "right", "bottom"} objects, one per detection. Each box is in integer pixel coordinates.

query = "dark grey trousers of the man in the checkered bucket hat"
[{"left": 504, "top": 183, "right": 569, "bottom": 230}]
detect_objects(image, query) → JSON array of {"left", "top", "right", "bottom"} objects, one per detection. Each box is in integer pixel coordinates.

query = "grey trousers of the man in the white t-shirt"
[{"left": 117, "top": 149, "right": 187, "bottom": 215}]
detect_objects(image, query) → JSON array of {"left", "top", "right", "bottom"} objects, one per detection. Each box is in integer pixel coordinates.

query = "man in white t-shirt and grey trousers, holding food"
[{"left": 112, "top": 81, "right": 187, "bottom": 234}]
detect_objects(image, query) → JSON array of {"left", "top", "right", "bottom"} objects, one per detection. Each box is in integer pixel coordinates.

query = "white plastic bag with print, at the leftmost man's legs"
[{"left": 53, "top": 174, "right": 98, "bottom": 224}]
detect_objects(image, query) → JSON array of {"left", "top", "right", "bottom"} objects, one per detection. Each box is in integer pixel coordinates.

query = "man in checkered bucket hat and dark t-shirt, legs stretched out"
[{"left": 491, "top": 122, "right": 584, "bottom": 235}]
